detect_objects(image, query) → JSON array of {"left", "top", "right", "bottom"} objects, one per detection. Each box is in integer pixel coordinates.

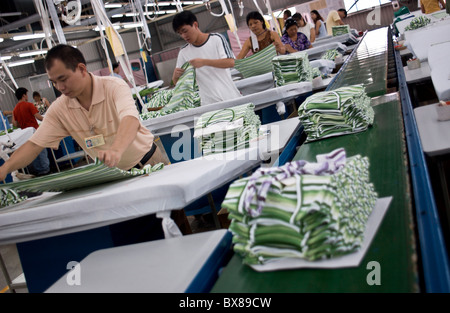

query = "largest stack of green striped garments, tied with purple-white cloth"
[{"left": 222, "top": 149, "right": 377, "bottom": 265}]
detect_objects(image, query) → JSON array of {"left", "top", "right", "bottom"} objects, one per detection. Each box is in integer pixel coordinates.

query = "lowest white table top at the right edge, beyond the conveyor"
[{"left": 414, "top": 104, "right": 450, "bottom": 156}]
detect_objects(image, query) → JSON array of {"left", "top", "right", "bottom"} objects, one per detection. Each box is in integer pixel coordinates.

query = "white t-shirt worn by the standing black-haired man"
[{"left": 176, "top": 33, "right": 242, "bottom": 105}]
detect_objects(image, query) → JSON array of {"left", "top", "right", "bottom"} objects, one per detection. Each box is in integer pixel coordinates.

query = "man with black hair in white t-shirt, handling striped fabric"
[{"left": 172, "top": 11, "right": 241, "bottom": 105}]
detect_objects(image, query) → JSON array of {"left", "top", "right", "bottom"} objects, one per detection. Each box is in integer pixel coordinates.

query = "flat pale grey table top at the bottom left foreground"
[{"left": 46, "top": 229, "right": 232, "bottom": 293}]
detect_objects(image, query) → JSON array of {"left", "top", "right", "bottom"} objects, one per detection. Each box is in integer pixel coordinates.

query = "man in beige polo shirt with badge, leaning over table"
[{"left": 0, "top": 45, "right": 190, "bottom": 232}]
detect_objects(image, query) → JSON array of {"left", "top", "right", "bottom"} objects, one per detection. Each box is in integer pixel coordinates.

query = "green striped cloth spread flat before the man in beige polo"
[{"left": 0, "top": 159, "right": 164, "bottom": 207}]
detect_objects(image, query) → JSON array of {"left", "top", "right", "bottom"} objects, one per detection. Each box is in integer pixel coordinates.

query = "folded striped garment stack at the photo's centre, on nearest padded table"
[{"left": 194, "top": 103, "right": 261, "bottom": 155}]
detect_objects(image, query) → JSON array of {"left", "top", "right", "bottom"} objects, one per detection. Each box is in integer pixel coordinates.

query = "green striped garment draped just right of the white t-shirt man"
[{"left": 234, "top": 45, "right": 277, "bottom": 78}]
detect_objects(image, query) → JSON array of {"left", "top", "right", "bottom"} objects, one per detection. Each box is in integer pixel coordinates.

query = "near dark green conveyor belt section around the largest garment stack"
[{"left": 212, "top": 100, "right": 419, "bottom": 292}]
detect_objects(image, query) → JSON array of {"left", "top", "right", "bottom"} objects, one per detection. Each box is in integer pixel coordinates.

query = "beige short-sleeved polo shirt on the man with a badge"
[{"left": 30, "top": 74, "right": 154, "bottom": 170}]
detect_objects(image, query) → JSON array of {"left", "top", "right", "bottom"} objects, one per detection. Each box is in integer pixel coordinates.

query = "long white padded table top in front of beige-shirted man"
[{"left": 0, "top": 118, "right": 300, "bottom": 245}]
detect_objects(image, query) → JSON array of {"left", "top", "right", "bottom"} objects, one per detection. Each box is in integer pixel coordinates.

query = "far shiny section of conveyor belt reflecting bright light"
[{"left": 327, "top": 28, "right": 388, "bottom": 97}]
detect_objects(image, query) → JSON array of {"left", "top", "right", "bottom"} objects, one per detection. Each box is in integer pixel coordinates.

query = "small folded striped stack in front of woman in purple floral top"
[{"left": 272, "top": 52, "right": 313, "bottom": 87}]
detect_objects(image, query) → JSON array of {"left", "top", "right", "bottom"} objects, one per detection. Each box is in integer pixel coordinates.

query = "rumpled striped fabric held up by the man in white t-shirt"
[{"left": 141, "top": 62, "right": 200, "bottom": 120}]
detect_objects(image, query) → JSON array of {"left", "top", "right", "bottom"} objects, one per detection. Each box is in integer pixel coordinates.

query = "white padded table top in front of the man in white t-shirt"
[{"left": 142, "top": 82, "right": 312, "bottom": 136}]
